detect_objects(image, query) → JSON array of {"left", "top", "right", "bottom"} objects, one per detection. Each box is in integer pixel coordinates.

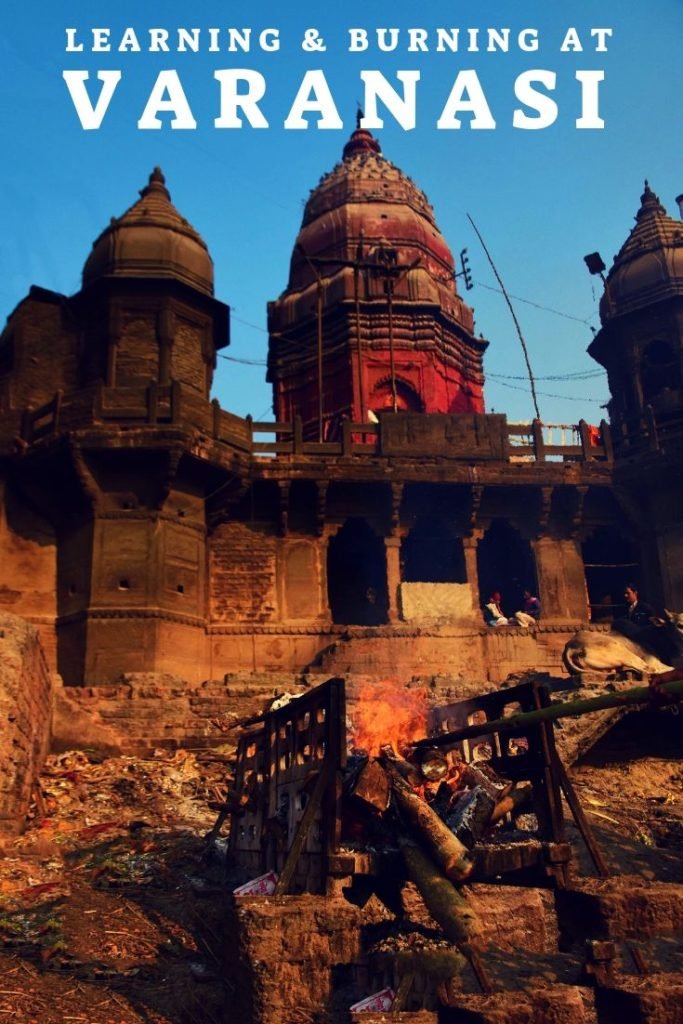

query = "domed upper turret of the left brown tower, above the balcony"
[{"left": 80, "top": 167, "right": 228, "bottom": 398}]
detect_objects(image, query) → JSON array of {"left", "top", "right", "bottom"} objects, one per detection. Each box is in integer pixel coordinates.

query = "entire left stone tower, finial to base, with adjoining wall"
[{"left": 0, "top": 168, "right": 235, "bottom": 683}]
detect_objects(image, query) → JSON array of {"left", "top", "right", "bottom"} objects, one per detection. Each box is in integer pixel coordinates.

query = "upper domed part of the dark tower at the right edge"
[{"left": 589, "top": 181, "right": 683, "bottom": 451}]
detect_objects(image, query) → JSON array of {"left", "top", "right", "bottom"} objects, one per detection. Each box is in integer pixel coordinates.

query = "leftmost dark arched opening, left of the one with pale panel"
[{"left": 328, "top": 519, "right": 389, "bottom": 626}]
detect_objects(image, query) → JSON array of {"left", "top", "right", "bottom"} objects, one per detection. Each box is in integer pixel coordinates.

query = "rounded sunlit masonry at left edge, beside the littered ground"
[{"left": 0, "top": 612, "right": 52, "bottom": 835}]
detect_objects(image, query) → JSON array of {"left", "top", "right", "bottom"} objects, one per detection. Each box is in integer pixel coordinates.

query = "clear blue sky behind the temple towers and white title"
[{"left": 0, "top": 0, "right": 683, "bottom": 423}]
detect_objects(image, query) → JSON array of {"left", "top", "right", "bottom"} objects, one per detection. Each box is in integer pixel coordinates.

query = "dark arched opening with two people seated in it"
[{"left": 477, "top": 519, "right": 537, "bottom": 615}]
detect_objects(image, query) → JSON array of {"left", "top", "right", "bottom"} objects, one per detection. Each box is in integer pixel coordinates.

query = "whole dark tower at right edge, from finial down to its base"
[{"left": 589, "top": 182, "right": 683, "bottom": 609}]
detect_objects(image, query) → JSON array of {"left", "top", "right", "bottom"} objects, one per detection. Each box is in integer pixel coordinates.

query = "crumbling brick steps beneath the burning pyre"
[{"left": 228, "top": 877, "right": 683, "bottom": 1024}]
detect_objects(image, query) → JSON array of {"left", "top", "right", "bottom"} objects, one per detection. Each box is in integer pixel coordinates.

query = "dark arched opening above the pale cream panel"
[{"left": 400, "top": 516, "right": 467, "bottom": 583}]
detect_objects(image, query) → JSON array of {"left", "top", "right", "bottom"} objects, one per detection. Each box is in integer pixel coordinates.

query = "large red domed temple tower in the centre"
[{"left": 268, "top": 127, "right": 486, "bottom": 438}]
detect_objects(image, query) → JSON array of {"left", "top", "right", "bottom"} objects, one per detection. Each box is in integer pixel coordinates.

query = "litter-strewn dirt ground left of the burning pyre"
[{"left": 0, "top": 748, "right": 231, "bottom": 1024}]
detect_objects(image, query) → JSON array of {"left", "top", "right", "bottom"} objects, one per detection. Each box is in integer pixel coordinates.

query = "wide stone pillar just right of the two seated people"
[{"left": 531, "top": 537, "right": 588, "bottom": 623}]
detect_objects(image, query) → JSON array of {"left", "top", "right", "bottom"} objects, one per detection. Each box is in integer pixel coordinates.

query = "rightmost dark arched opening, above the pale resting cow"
[{"left": 582, "top": 525, "right": 640, "bottom": 622}]
